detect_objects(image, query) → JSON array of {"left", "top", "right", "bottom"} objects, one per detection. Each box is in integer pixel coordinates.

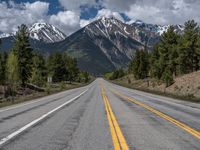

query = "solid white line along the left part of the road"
[{"left": 0, "top": 89, "right": 88, "bottom": 147}]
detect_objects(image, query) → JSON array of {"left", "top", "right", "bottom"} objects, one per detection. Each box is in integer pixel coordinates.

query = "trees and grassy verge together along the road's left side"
[{"left": 0, "top": 25, "right": 91, "bottom": 107}]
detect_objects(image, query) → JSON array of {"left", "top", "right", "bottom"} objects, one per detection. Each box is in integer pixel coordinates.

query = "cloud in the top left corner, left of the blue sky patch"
[{"left": 0, "top": 1, "right": 49, "bottom": 33}]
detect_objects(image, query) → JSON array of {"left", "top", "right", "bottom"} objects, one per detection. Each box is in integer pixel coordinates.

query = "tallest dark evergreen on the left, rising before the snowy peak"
[{"left": 14, "top": 24, "right": 33, "bottom": 87}]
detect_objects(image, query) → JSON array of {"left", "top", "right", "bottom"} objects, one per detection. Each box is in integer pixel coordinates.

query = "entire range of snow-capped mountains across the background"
[{"left": 0, "top": 17, "right": 183, "bottom": 75}]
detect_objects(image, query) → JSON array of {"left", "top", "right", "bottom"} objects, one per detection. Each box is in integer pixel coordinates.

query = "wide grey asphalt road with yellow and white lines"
[{"left": 0, "top": 79, "right": 200, "bottom": 150}]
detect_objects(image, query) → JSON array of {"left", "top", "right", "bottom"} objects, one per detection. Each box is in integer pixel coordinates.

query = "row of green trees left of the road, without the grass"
[{"left": 0, "top": 24, "right": 89, "bottom": 96}]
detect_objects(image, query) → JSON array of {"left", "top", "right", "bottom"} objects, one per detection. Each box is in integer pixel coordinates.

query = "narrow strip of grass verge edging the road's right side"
[{"left": 110, "top": 80, "right": 200, "bottom": 103}]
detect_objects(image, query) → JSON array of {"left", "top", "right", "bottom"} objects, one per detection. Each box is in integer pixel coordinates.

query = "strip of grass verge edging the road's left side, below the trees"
[{"left": 0, "top": 80, "right": 93, "bottom": 108}]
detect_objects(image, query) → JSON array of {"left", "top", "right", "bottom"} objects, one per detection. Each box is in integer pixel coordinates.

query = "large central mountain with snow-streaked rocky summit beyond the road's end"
[{"left": 55, "top": 17, "right": 148, "bottom": 74}]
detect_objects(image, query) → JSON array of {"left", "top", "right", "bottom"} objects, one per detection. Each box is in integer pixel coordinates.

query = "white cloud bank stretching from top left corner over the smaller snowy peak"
[{"left": 0, "top": 1, "right": 80, "bottom": 35}]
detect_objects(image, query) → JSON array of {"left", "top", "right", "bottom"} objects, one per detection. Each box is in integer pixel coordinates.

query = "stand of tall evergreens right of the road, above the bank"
[{"left": 128, "top": 20, "right": 200, "bottom": 86}]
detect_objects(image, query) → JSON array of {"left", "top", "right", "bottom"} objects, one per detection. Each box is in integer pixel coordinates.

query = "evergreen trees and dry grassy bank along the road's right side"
[{"left": 106, "top": 20, "right": 200, "bottom": 100}]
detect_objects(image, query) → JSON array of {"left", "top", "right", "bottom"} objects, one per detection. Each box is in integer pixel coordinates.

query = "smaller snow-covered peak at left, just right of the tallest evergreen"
[{"left": 29, "top": 23, "right": 66, "bottom": 43}]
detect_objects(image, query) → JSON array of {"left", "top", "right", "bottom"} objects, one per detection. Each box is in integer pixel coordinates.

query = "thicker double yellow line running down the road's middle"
[{"left": 101, "top": 88, "right": 129, "bottom": 150}]
